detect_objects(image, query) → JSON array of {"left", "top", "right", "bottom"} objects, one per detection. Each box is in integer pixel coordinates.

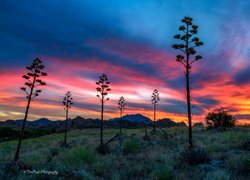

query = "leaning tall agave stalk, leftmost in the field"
[{"left": 14, "top": 58, "right": 47, "bottom": 162}]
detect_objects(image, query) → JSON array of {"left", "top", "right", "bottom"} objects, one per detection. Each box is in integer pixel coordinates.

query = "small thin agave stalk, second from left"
[{"left": 63, "top": 92, "right": 73, "bottom": 145}]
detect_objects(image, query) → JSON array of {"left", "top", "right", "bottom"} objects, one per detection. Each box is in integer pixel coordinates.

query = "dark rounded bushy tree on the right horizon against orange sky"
[{"left": 206, "top": 110, "right": 236, "bottom": 128}]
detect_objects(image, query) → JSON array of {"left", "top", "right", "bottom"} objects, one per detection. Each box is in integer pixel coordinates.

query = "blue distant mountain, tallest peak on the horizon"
[{"left": 109, "top": 114, "right": 152, "bottom": 124}]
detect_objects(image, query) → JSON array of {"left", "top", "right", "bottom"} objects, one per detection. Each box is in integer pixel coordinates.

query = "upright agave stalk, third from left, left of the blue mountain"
[{"left": 96, "top": 74, "right": 111, "bottom": 152}]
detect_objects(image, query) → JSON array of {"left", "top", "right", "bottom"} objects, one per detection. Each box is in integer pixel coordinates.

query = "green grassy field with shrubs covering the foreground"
[{"left": 0, "top": 127, "right": 250, "bottom": 180}]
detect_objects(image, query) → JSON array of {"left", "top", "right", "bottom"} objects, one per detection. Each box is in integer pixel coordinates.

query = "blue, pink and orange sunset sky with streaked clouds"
[{"left": 0, "top": 0, "right": 250, "bottom": 124}]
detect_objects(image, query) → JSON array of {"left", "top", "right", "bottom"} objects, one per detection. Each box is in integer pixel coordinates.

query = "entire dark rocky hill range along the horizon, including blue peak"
[{"left": 0, "top": 114, "right": 186, "bottom": 131}]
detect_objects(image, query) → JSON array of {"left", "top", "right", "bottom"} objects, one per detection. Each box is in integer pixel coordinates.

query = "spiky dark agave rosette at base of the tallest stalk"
[{"left": 180, "top": 147, "right": 210, "bottom": 165}]
